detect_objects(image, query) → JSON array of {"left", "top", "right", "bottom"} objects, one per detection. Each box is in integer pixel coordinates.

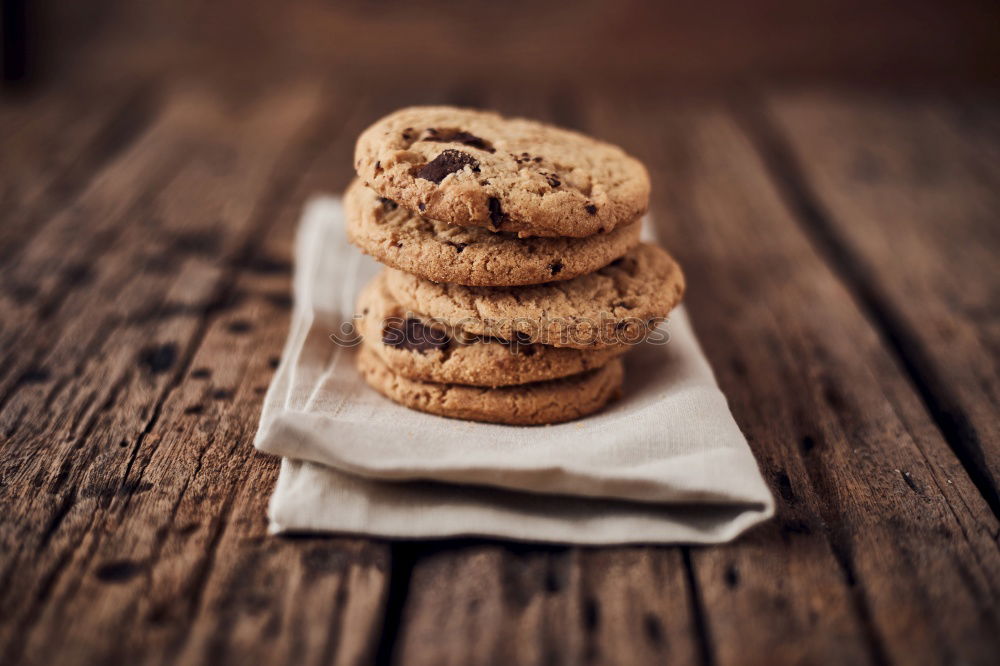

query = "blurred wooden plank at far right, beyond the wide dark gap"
[{"left": 764, "top": 95, "right": 1000, "bottom": 514}]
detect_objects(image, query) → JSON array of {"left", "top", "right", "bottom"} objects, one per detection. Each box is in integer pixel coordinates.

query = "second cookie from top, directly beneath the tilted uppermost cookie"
[{"left": 344, "top": 180, "right": 642, "bottom": 286}]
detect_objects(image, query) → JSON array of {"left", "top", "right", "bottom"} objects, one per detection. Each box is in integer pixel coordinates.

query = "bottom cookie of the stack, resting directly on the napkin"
[{"left": 358, "top": 345, "right": 625, "bottom": 425}]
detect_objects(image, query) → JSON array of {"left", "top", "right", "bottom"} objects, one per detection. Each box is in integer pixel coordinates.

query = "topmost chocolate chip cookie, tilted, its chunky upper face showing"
[{"left": 354, "top": 106, "right": 649, "bottom": 237}]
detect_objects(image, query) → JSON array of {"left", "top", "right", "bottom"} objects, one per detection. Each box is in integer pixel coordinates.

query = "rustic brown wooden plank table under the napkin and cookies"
[{"left": 0, "top": 81, "right": 1000, "bottom": 665}]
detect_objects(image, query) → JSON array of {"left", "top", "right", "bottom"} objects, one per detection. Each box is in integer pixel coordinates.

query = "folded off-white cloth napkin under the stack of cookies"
[{"left": 255, "top": 197, "right": 774, "bottom": 544}]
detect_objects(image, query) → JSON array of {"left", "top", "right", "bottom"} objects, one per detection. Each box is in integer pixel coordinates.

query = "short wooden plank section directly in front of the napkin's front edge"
[{"left": 394, "top": 543, "right": 698, "bottom": 665}]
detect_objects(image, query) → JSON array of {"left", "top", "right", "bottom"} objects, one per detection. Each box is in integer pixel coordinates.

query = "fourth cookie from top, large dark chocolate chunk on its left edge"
[{"left": 357, "top": 272, "right": 628, "bottom": 387}]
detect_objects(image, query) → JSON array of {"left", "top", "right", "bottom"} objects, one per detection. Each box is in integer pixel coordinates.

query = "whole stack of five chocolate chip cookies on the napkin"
[{"left": 345, "top": 107, "right": 684, "bottom": 425}]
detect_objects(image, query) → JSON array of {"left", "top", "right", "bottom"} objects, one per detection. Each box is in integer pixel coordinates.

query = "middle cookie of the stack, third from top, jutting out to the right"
[{"left": 385, "top": 243, "right": 684, "bottom": 349}]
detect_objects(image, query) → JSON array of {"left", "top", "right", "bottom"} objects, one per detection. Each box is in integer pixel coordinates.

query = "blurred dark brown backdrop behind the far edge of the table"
[{"left": 4, "top": 0, "right": 1000, "bottom": 96}]
